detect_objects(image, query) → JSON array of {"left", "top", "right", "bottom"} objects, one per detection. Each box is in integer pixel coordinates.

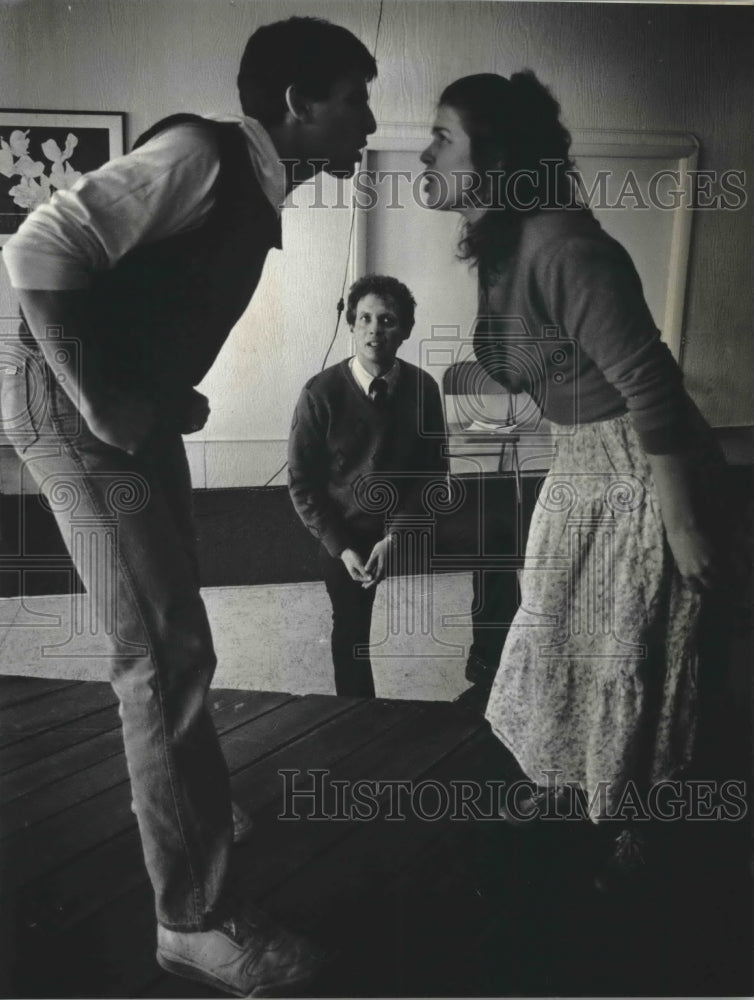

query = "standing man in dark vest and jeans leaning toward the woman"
[{"left": 2, "top": 18, "right": 376, "bottom": 996}]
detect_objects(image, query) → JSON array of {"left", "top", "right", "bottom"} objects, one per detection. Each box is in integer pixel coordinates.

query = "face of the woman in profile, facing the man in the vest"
[{"left": 419, "top": 104, "right": 477, "bottom": 212}]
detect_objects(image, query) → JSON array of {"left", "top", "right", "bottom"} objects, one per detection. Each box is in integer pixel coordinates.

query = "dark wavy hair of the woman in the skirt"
[{"left": 439, "top": 70, "right": 574, "bottom": 277}]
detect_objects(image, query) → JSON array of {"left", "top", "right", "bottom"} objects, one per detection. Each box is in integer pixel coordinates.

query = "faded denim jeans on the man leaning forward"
[{"left": 0, "top": 341, "right": 232, "bottom": 931}]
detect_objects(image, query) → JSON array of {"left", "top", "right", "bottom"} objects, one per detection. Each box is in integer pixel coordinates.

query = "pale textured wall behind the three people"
[{"left": 0, "top": 0, "right": 754, "bottom": 489}]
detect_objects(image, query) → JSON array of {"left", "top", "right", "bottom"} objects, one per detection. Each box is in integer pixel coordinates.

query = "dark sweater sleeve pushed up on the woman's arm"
[{"left": 541, "top": 238, "right": 686, "bottom": 454}]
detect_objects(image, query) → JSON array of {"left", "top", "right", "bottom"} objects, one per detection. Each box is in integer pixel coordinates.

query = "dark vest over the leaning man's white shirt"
[{"left": 85, "top": 115, "right": 281, "bottom": 402}]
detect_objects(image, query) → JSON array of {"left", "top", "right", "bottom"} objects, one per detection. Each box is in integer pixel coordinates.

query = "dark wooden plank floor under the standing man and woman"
[{"left": 0, "top": 677, "right": 753, "bottom": 997}]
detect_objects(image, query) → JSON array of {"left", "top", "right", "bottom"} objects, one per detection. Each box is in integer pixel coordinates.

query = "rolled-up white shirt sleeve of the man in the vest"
[{"left": 2, "top": 123, "right": 219, "bottom": 291}]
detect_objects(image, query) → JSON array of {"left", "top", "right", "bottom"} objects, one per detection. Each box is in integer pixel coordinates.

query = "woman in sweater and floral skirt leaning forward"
[{"left": 421, "top": 71, "right": 720, "bottom": 889}]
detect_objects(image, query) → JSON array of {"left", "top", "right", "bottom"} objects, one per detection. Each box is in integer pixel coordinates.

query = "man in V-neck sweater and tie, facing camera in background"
[{"left": 288, "top": 275, "right": 448, "bottom": 698}]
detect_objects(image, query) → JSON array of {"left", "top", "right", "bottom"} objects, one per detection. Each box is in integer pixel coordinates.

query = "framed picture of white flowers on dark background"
[{"left": 0, "top": 109, "right": 126, "bottom": 246}]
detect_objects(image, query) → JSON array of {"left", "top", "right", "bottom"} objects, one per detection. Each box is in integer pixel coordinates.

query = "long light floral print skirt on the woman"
[{"left": 486, "top": 416, "right": 701, "bottom": 822}]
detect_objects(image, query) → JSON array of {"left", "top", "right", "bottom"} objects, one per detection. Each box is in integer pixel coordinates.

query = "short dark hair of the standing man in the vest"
[{"left": 238, "top": 17, "right": 377, "bottom": 126}]
